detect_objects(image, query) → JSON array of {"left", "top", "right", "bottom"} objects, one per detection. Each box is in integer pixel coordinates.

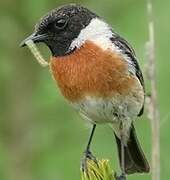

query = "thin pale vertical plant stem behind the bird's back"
[{"left": 147, "top": 0, "right": 160, "bottom": 180}]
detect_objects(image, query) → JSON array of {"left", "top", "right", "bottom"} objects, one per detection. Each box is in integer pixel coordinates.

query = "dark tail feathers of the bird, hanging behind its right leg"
[{"left": 115, "top": 126, "right": 150, "bottom": 174}]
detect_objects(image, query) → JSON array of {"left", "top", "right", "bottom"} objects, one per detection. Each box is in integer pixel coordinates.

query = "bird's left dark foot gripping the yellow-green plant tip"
[{"left": 81, "top": 150, "right": 97, "bottom": 173}]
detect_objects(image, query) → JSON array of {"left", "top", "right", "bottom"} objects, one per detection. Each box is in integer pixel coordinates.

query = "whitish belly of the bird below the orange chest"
[{"left": 73, "top": 91, "right": 144, "bottom": 123}]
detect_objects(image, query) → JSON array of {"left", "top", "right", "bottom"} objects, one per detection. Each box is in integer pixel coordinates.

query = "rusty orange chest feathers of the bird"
[{"left": 50, "top": 41, "right": 135, "bottom": 102}]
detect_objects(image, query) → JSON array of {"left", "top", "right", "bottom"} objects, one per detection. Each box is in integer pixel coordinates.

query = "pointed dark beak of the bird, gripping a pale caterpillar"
[{"left": 20, "top": 33, "right": 49, "bottom": 47}]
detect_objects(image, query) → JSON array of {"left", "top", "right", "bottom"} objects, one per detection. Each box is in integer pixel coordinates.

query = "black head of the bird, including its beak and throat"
[{"left": 21, "top": 4, "right": 97, "bottom": 56}]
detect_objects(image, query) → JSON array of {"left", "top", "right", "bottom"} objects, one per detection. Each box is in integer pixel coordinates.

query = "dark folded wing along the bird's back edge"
[{"left": 111, "top": 33, "right": 145, "bottom": 116}]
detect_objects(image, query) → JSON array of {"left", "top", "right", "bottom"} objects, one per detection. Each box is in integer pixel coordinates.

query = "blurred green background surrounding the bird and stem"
[{"left": 0, "top": 0, "right": 170, "bottom": 180}]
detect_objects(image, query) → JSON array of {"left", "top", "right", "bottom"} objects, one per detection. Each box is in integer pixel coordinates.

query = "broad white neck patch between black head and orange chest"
[{"left": 70, "top": 18, "right": 113, "bottom": 50}]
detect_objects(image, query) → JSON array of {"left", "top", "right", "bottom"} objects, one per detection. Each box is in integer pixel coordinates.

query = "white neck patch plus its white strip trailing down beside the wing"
[{"left": 70, "top": 18, "right": 136, "bottom": 74}]
